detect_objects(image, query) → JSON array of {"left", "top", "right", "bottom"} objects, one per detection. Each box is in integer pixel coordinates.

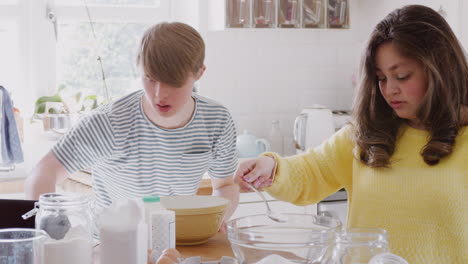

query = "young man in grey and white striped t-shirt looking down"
[{"left": 26, "top": 23, "right": 239, "bottom": 229}]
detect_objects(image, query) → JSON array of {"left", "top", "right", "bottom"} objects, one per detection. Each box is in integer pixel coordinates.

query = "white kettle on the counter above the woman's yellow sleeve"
[{"left": 294, "top": 105, "right": 335, "bottom": 153}]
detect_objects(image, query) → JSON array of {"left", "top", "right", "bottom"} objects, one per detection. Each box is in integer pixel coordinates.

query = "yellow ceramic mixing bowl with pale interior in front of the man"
[{"left": 161, "top": 195, "right": 229, "bottom": 245}]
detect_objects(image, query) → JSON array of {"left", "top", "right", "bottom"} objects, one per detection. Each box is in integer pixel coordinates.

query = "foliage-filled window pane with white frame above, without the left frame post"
[{"left": 51, "top": 0, "right": 171, "bottom": 100}]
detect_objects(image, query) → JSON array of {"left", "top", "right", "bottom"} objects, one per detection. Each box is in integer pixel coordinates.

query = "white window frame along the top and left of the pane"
[{"left": 0, "top": 0, "right": 174, "bottom": 117}]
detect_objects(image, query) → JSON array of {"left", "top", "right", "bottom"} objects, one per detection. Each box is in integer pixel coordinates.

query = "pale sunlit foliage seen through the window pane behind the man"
[{"left": 57, "top": 22, "right": 150, "bottom": 99}]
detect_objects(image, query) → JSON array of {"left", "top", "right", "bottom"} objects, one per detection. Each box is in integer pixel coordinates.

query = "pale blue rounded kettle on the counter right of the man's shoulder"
[{"left": 236, "top": 130, "right": 270, "bottom": 158}]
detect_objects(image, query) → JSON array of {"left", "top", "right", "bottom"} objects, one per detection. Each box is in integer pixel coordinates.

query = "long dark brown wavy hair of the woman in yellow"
[{"left": 353, "top": 5, "right": 468, "bottom": 168}]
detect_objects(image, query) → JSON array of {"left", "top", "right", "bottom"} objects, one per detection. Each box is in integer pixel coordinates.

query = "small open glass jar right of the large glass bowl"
[{"left": 332, "top": 227, "right": 388, "bottom": 264}]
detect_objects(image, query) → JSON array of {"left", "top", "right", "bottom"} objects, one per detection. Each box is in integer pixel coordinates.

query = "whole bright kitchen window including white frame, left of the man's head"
[{"left": 0, "top": 0, "right": 173, "bottom": 113}]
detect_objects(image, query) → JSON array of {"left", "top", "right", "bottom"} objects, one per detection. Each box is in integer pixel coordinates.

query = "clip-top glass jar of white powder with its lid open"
[{"left": 23, "top": 193, "right": 93, "bottom": 264}]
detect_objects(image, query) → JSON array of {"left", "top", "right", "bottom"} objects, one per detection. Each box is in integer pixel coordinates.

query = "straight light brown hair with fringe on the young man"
[{"left": 137, "top": 22, "right": 205, "bottom": 87}]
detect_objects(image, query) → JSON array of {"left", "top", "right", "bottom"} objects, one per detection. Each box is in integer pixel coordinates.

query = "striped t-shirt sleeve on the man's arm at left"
[{"left": 52, "top": 112, "right": 115, "bottom": 173}]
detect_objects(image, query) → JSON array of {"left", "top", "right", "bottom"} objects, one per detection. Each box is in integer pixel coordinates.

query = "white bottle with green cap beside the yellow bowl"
[{"left": 143, "top": 196, "right": 175, "bottom": 263}]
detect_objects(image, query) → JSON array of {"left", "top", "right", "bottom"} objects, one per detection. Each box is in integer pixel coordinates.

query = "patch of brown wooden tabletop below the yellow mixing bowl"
[{"left": 176, "top": 233, "right": 234, "bottom": 261}]
